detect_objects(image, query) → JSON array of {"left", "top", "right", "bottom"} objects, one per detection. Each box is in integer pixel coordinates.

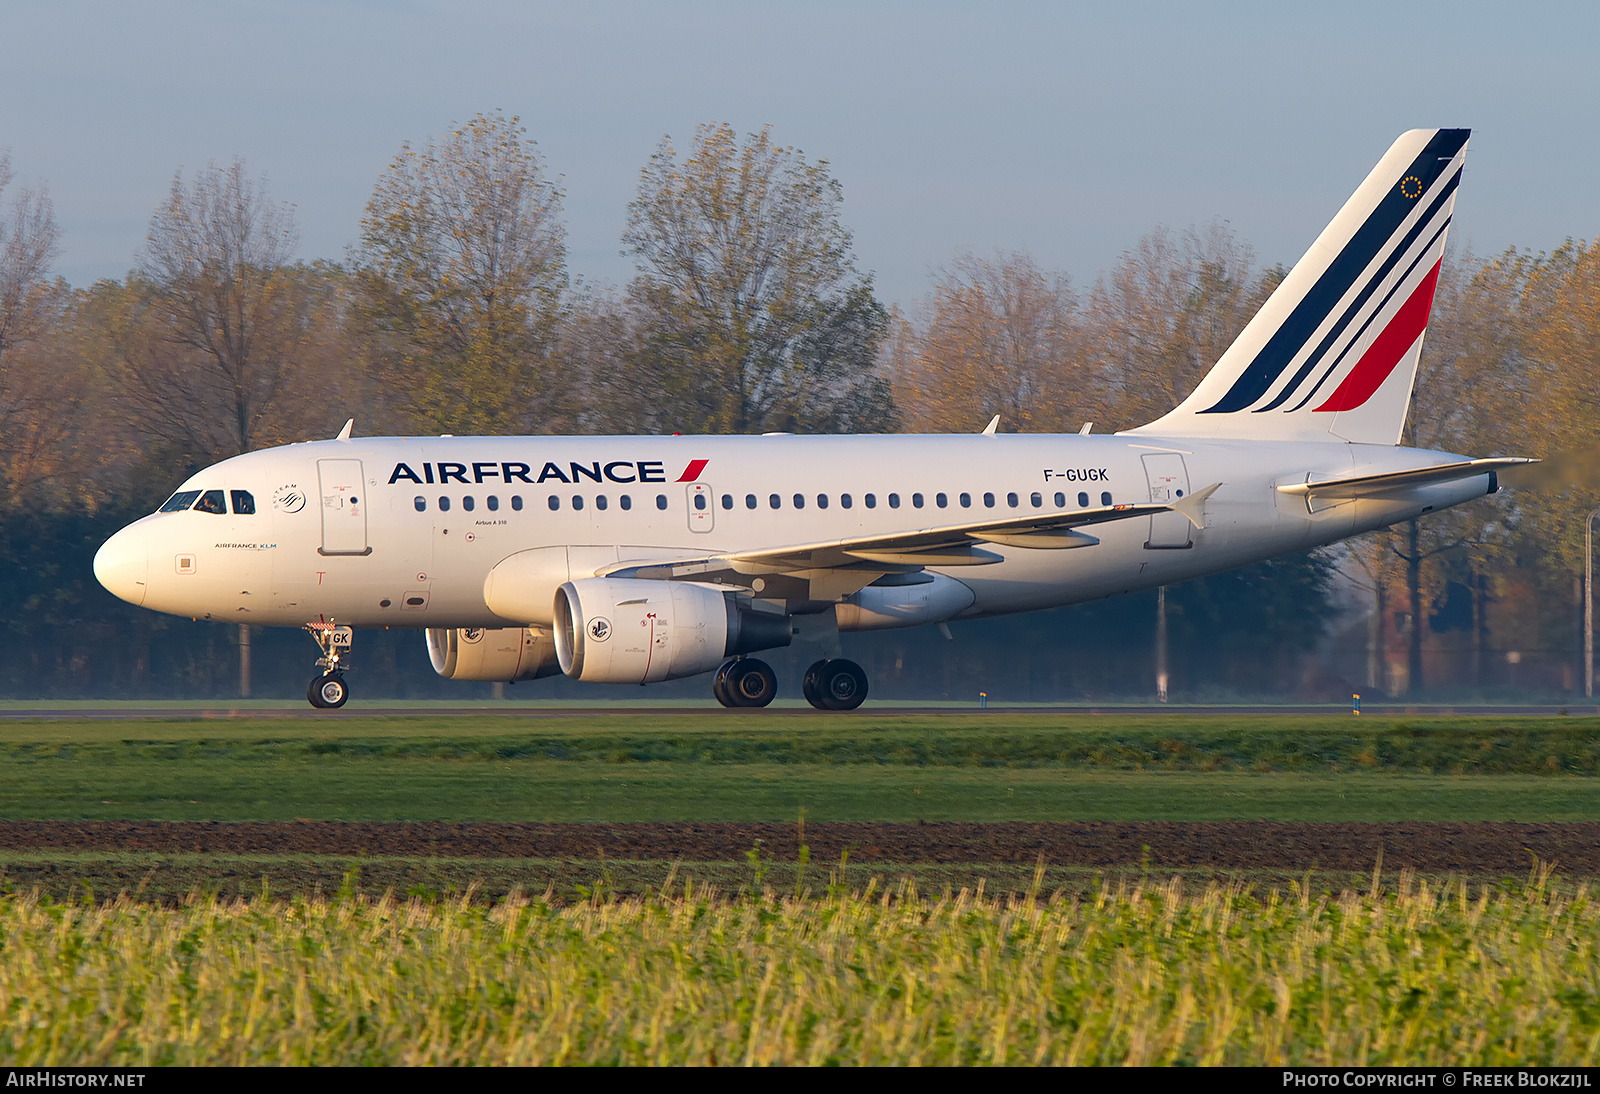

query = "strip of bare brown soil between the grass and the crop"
[{"left": 0, "top": 821, "right": 1600, "bottom": 876}]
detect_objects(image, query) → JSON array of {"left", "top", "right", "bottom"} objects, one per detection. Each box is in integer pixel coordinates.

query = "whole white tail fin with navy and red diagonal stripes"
[{"left": 1128, "top": 130, "right": 1470, "bottom": 445}]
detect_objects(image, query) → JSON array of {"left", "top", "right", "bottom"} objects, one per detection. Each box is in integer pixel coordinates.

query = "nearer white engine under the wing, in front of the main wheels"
[{"left": 555, "top": 577, "right": 794, "bottom": 683}]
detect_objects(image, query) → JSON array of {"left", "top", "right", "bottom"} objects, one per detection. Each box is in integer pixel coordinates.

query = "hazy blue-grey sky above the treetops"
[{"left": 0, "top": 0, "right": 1600, "bottom": 304}]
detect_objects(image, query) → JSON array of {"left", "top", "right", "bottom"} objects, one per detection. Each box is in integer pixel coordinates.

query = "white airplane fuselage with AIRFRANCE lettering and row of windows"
[{"left": 96, "top": 435, "right": 1488, "bottom": 629}]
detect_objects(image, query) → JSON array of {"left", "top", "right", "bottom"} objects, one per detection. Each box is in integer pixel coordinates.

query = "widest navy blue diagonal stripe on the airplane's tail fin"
[{"left": 1200, "top": 130, "right": 1467, "bottom": 414}]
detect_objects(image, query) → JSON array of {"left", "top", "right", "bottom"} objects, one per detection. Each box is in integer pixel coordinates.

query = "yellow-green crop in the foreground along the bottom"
[{"left": 0, "top": 870, "right": 1600, "bottom": 1067}]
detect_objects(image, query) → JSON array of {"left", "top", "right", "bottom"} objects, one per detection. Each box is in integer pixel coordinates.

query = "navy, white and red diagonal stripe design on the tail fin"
[{"left": 1200, "top": 130, "right": 1469, "bottom": 414}]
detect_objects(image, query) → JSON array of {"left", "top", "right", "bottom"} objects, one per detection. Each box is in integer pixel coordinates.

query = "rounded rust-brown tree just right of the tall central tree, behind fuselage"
[{"left": 894, "top": 251, "right": 1081, "bottom": 432}]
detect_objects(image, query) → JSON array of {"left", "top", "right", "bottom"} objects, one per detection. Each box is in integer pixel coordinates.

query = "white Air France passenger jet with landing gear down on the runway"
[{"left": 94, "top": 130, "right": 1533, "bottom": 710}]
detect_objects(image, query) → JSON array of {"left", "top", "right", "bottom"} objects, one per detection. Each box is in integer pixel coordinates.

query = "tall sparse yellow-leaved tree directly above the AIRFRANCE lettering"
[{"left": 357, "top": 112, "right": 570, "bottom": 432}]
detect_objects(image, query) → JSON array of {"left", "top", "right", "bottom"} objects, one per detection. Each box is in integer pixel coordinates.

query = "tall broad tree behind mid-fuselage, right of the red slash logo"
[{"left": 622, "top": 125, "right": 894, "bottom": 433}]
